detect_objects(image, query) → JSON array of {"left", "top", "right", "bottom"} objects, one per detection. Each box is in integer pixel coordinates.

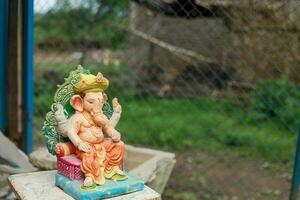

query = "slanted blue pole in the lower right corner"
[{"left": 290, "top": 126, "right": 300, "bottom": 200}]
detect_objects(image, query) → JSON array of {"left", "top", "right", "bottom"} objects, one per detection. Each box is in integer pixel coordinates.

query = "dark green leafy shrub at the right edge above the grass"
[{"left": 250, "top": 76, "right": 300, "bottom": 131}]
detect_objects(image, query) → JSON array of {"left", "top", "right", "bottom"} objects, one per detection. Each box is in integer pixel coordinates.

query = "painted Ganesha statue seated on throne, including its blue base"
[{"left": 43, "top": 66, "right": 144, "bottom": 199}]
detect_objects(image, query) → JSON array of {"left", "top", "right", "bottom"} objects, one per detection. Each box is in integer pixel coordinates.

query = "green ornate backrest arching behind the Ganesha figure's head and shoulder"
[{"left": 43, "top": 66, "right": 90, "bottom": 155}]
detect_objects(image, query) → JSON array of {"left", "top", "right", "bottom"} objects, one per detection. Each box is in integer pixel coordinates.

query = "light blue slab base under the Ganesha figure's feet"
[{"left": 55, "top": 172, "right": 144, "bottom": 200}]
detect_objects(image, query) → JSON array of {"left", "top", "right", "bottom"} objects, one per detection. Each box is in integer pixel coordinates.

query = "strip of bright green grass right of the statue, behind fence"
[{"left": 118, "top": 97, "right": 296, "bottom": 163}]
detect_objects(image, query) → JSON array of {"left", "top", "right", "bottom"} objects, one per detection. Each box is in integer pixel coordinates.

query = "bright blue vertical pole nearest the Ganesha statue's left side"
[{"left": 23, "top": 0, "right": 34, "bottom": 153}]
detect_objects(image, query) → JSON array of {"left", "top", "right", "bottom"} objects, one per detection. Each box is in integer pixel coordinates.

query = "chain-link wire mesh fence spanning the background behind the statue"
[{"left": 34, "top": 0, "right": 300, "bottom": 199}]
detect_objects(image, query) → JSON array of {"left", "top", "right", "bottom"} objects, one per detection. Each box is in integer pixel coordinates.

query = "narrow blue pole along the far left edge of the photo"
[{"left": 0, "top": 0, "right": 8, "bottom": 132}]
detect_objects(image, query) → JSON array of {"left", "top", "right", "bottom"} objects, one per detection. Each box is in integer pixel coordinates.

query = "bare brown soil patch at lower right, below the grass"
[{"left": 163, "top": 151, "right": 291, "bottom": 200}]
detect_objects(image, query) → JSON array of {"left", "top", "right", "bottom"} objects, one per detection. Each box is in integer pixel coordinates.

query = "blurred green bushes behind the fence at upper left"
[{"left": 35, "top": 0, "right": 128, "bottom": 49}]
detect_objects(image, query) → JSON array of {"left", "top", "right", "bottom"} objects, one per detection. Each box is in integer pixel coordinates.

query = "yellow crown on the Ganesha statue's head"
[{"left": 73, "top": 73, "right": 109, "bottom": 93}]
